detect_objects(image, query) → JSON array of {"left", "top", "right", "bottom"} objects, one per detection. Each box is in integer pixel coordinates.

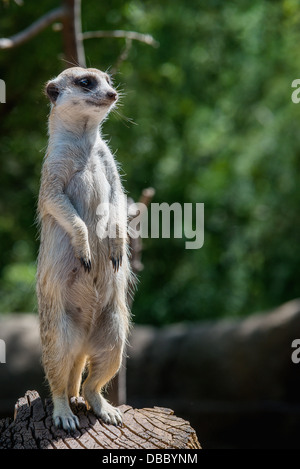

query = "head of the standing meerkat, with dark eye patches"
[{"left": 45, "top": 67, "right": 118, "bottom": 122}]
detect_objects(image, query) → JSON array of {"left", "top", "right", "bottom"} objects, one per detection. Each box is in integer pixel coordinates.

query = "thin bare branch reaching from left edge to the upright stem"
[{"left": 0, "top": 7, "right": 66, "bottom": 49}]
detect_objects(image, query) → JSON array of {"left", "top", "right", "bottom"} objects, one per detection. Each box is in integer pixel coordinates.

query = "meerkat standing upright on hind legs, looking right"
[{"left": 37, "top": 67, "right": 131, "bottom": 431}]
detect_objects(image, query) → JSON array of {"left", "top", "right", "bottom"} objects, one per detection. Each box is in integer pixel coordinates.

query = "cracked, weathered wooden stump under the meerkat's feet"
[{"left": 0, "top": 391, "right": 201, "bottom": 450}]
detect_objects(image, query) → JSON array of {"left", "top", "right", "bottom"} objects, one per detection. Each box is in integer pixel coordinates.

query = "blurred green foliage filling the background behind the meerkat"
[{"left": 0, "top": 0, "right": 300, "bottom": 325}]
